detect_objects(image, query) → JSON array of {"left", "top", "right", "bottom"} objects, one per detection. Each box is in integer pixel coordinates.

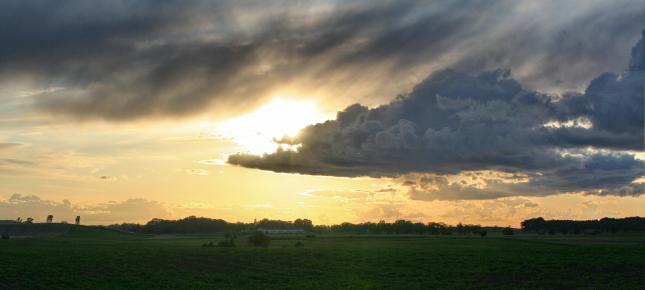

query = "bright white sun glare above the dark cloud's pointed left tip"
[{"left": 218, "top": 97, "right": 330, "bottom": 154}]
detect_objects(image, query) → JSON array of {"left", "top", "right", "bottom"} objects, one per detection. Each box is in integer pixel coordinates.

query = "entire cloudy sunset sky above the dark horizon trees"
[{"left": 0, "top": 0, "right": 645, "bottom": 226}]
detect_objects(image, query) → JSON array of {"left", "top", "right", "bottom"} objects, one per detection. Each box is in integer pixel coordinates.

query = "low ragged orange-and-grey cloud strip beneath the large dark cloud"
[{"left": 406, "top": 154, "right": 645, "bottom": 200}]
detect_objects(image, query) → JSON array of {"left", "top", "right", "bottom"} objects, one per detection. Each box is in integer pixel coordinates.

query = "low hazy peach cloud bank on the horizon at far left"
[{"left": 0, "top": 194, "right": 170, "bottom": 224}]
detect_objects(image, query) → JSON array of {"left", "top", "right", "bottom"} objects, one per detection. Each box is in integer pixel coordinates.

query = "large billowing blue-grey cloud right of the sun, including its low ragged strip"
[{"left": 228, "top": 32, "right": 645, "bottom": 199}]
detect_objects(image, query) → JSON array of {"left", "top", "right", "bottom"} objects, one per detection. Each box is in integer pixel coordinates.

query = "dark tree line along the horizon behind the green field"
[{"left": 108, "top": 216, "right": 645, "bottom": 235}]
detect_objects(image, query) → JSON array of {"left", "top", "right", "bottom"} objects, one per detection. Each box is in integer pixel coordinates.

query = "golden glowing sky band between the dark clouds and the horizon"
[{"left": 0, "top": 93, "right": 645, "bottom": 226}]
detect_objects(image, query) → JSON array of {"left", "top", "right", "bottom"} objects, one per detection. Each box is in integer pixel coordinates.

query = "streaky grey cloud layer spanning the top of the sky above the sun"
[{"left": 0, "top": 0, "right": 642, "bottom": 120}]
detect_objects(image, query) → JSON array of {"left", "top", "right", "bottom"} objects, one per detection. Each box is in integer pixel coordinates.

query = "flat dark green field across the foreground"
[{"left": 0, "top": 227, "right": 645, "bottom": 289}]
